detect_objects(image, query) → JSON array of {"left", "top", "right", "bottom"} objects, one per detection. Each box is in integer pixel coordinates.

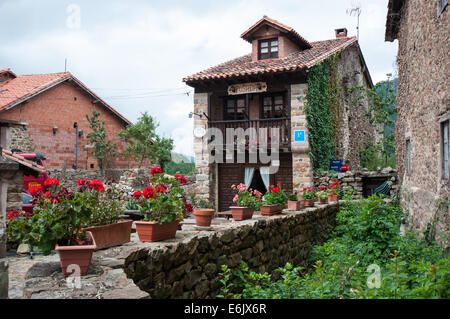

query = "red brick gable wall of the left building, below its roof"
[{"left": 0, "top": 82, "right": 136, "bottom": 169}]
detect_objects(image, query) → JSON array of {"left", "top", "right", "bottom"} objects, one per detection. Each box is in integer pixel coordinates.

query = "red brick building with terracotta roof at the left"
[{"left": 0, "top": 69, "right": 134, "bottom": 169}]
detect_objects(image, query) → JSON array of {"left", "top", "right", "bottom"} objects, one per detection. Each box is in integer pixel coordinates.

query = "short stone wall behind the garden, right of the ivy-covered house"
[{"left": 314, "top": 167, "right": 399, "bottom": 197}]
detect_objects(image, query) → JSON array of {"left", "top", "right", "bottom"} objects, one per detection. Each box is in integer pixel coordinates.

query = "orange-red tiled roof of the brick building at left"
[{"left": 0, "top": 72, "right": 131, "bottom": 124}]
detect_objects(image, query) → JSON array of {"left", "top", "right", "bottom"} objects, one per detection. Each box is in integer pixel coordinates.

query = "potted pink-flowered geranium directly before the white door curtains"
[{"left": 230, "top": 183, "right": 262, "bottom": 221}]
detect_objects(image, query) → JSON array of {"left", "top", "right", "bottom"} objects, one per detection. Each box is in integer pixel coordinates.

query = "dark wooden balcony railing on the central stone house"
[{"left": 208, "top": 117, "right": 291, "bottom": 146}]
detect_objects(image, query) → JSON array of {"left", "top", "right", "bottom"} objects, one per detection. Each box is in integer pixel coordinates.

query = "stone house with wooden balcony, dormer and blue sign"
[{"left": 183, "top": 16, "right": 376, "bottom": 211}]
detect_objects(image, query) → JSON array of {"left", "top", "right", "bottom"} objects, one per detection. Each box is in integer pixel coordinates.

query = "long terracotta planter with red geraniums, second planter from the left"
[{"left": 77, "top": 179, "right": 133, "bottom": 249}]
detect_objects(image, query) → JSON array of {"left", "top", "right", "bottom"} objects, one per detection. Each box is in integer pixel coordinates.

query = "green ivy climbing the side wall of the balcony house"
[{"left": 305, "top": 53, "right": 341, "bottom": 172}]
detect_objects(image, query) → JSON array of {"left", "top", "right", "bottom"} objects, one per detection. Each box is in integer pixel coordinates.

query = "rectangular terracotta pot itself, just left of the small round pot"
[{"left": 134, "top": 220, "right": 178, "bottom": 243}]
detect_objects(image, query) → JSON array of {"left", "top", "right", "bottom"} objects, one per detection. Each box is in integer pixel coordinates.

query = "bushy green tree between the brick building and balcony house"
[{"left": 119, "top": 112, "right": 173, "bottom": 170}]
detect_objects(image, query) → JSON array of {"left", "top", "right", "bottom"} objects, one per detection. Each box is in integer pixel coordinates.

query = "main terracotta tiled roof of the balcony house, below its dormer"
[{"left": 183, "top": 37, "right": 357, "bottom": 83}]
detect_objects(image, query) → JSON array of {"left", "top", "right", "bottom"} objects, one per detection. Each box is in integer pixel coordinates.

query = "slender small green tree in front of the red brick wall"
[{"left": 86, "top": 108, "right": 117, "bottom": 171}]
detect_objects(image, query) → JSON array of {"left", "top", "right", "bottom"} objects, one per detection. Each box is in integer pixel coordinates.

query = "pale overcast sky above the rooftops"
[{"left": 0, "top": 0, "right": 398, "bottom": 155}]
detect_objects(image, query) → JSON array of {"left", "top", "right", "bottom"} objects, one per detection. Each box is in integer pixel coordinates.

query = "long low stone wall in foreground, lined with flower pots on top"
[{"left": 124, "top": 204, "right": 338, "bottom": 299}]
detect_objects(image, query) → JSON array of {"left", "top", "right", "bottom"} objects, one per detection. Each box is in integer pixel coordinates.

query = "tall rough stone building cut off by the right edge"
[{"left": 386, "top": 0, "right": 450, "bottom": 242}]
